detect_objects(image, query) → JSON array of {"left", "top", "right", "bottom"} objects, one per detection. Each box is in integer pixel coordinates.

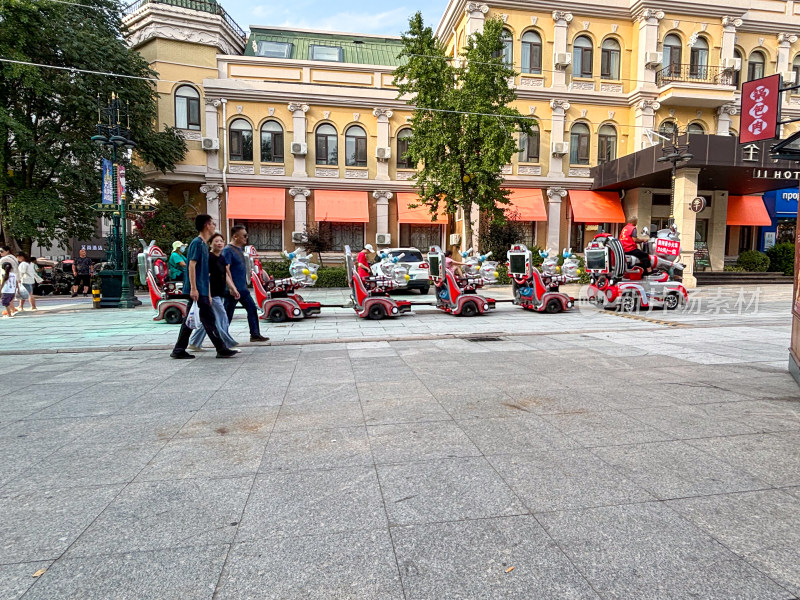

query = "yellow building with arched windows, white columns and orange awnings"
[{"left": 125, "top": 0, "right": 800, "bottom": 284}]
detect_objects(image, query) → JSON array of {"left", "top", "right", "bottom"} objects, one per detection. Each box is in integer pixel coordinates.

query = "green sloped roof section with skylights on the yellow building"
[{"left": 244, "top": 28, "right": 403, "bottom": 67}]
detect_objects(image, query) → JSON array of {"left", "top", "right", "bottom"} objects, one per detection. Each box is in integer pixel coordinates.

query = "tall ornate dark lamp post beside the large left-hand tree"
[{"left": 92, "top": 94, "right": 139, "bottom": 308}]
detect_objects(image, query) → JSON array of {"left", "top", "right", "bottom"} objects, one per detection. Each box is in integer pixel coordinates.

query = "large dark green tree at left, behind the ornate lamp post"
[{"left": 0, "top": 0, "right": 186, "bottom": 251}]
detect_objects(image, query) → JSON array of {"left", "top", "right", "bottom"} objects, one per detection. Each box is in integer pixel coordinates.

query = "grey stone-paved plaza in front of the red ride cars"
[{"left": 0, "top": 286, "right": 800, "bottom": 600}]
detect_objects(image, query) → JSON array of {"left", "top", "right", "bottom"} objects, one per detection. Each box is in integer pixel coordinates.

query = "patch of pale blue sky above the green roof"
[{"left": 220, "top": 0, "right": 447, "bottom": 35}]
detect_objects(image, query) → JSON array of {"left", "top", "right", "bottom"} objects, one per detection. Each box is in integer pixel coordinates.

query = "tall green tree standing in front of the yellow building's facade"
[{"left": 395, "top": 13, "right": 535, "bottom": 250}]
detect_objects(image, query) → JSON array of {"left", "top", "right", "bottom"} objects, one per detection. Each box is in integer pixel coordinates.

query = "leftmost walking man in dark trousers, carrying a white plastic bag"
[{"left": 170, "top": 215, "right": 237, "bottom": 358}]
